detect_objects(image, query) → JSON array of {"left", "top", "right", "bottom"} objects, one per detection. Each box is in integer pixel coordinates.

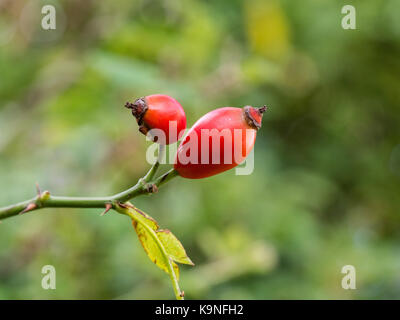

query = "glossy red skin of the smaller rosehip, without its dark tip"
[{"left": 143, "top": 94, "right": 186, "bottom": 144}]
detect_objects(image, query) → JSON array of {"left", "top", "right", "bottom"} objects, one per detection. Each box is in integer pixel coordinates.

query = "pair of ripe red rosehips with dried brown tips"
[{"left": 125, "top": 94, "right": 266, "bottom": 179}]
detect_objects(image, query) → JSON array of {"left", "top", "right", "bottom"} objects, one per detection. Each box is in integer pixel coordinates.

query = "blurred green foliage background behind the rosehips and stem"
[{"left": 0, "top": 0, "right": 400, "bottom": 299}]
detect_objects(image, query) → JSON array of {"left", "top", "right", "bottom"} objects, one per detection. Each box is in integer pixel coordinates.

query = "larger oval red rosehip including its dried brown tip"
[{"left": 174, "top": 106, "right": 267, "bottom": 179}]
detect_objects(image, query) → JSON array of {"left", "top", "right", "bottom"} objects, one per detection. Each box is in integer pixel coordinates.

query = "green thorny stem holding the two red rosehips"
[{"left": 0, "top": 147, "right": 178, "bottom": 221}]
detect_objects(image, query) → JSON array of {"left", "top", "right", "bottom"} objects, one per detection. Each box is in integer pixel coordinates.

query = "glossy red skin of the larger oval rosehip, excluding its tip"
[{"left": 174, "top": 107, "right": 257, "bottom": 179}]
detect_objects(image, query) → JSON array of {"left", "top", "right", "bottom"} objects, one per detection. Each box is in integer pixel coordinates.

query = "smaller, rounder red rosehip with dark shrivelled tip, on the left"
[{"left": 125, "top": 94, "right": 186, "bottom": 144}]
